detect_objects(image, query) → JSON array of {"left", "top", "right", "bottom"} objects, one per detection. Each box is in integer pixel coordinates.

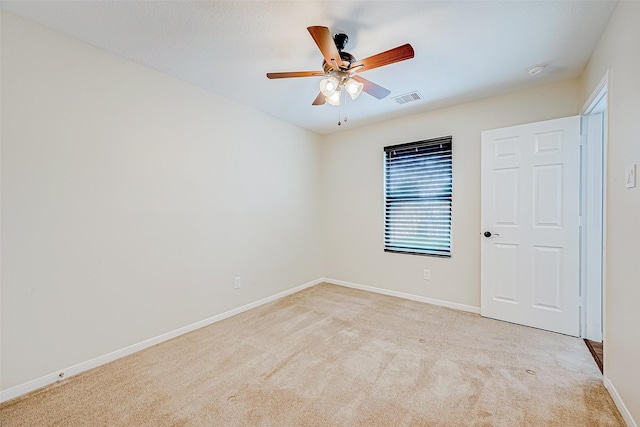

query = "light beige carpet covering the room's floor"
[{"left": 0, "top": 284, "right": 624, "bottom": 427}]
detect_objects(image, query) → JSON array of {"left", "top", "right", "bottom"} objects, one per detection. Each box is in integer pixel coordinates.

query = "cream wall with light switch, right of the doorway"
[{"left": 582, "top": 1, "right": 640, "bottom": 424}]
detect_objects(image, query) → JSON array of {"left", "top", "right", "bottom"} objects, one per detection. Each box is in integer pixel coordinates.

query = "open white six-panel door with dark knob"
[{"left": 481, "top": 116, "right": 580, "bottom": 336}]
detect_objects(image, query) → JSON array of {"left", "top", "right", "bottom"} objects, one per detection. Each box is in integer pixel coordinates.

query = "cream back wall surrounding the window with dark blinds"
[{"left": 322, "top": 79, "right": 580, "bottom": 308}]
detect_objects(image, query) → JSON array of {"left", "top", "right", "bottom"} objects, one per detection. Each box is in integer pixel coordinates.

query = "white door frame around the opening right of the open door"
[{"left": 580, "top": 72, "right": 609, "bottom": 348}]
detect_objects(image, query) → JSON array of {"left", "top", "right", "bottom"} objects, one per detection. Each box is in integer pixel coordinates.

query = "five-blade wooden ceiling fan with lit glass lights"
[{"left": 267, "top": 26, "right": 413, "bottom": 105}]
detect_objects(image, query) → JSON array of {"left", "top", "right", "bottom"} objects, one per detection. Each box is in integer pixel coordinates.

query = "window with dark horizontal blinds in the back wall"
[{"left": 384, "top": 136, "right": 452, "bottom": 257}]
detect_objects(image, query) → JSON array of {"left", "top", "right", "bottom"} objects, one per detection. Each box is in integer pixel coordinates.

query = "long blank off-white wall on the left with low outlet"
[{"left": 0, "top": 12, "right": 322, "bottom": 390}]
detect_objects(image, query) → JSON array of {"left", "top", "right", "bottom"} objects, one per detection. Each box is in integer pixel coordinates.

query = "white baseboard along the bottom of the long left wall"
[{"left": 0, "top": 279, "right": 324, "bottom": 402}]
